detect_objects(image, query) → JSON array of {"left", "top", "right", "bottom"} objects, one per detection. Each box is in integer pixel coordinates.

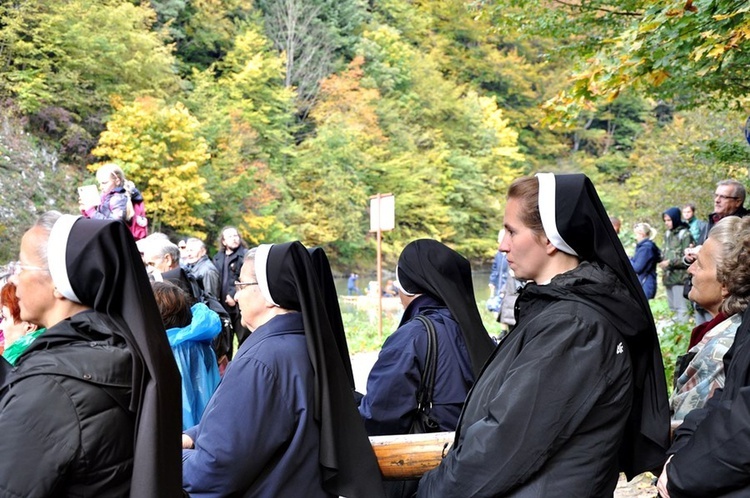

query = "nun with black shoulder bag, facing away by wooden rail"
[{"left": 359, "top": 239, "right": 495, "bottom": 436}]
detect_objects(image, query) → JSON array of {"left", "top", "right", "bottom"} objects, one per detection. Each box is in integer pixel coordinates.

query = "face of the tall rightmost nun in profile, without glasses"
[{"left": 500, "top": 198, "right": 551, "bottom": 283}]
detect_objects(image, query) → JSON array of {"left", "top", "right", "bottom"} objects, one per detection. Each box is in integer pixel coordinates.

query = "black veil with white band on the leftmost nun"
[{"left": 48, "top": 215, "right": 182, "bottom": 498}]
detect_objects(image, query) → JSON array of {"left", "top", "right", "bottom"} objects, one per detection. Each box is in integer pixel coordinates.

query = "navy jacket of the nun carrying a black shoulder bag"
[{"left": 359, "top": 295, "right": 474, "bottom": 436}]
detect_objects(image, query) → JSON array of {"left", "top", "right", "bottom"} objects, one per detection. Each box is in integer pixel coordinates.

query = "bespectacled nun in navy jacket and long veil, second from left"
[{"left": 183, "top": 242, "right": 383, "bottom": 498}]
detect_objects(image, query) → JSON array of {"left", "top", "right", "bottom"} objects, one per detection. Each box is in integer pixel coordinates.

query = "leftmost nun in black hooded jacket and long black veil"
[{"left": 0, "top": 211, "right": 182, "bottom": 498}]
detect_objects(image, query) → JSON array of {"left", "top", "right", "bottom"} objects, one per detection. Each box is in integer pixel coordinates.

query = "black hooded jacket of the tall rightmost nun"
[{"left": 417, "top": 262, "right": 646, "bottom": 498}]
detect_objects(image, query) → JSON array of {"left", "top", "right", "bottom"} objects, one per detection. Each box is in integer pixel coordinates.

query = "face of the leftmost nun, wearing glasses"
[{"left": 15, "top": 227, "right": 56, "bottom": 327}]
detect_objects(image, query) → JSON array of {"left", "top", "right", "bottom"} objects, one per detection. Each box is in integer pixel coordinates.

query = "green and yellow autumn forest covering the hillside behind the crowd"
[{"left": 0, "top": 0, "right": 750, "bottom": 267}]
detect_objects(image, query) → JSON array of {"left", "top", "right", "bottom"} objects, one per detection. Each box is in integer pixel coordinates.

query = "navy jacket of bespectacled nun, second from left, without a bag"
[{"left": 182, "top": 313, "right": 331, "bottom": 498}]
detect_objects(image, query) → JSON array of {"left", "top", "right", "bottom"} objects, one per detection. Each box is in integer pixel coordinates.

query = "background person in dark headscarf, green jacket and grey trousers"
[{"left": 659, "top": 207, "right": 693, "bottom": 323}]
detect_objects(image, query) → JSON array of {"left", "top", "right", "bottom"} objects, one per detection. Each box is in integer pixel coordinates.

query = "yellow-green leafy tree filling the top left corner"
[{"left": 0, "top": 0, "right": 177, "bottom": 117}]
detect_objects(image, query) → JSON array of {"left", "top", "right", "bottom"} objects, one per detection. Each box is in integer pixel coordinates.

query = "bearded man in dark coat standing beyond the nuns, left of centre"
[{"left": 213, "top": 226, "right": 250, "bottom": 346}]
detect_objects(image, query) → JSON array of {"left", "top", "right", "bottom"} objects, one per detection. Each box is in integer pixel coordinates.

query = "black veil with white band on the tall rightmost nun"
[{"left": 537, "top": 173, "right": 669, "bottom": 478}]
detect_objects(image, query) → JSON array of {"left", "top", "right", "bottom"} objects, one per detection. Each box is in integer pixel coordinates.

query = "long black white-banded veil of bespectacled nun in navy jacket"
[{"left": 255, "top": 242, "right": 383, "bottom": 498}]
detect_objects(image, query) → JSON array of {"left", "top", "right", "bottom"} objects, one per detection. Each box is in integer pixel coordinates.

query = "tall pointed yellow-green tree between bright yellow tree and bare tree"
[{"left": 187, "top": 23, "right": 294, "bottom": 242}]
